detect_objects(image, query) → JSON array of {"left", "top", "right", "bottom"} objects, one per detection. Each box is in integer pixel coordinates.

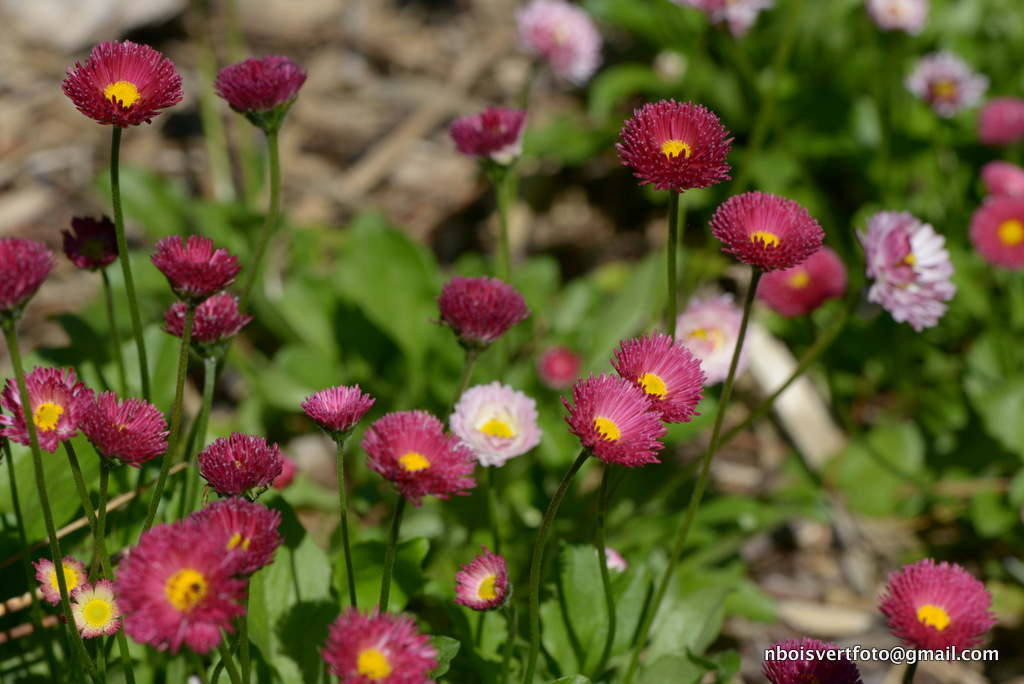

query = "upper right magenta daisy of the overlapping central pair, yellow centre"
[{"left": 611, "top": 333, "right": 705, "bottom": 423}]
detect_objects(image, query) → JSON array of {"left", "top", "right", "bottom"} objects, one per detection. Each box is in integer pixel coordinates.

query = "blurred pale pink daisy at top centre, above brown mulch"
[{"left": 515, "top": 0, "right": 601, "bottom": 86}]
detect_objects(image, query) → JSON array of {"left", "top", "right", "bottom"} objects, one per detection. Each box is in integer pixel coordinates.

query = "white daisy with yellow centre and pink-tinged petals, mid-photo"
[{"left": 450, "top": 380, "right": 541, "bottom": 467}]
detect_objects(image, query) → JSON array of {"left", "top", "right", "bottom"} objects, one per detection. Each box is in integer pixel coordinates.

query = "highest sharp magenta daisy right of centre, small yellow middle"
[{"left": 615, "top": 99, "right": 732, "bottom": 193}]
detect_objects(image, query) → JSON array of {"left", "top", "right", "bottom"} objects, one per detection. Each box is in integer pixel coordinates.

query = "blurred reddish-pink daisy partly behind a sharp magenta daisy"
[{"left": 758, "top": 247, "right": 846, "bottom": 318}]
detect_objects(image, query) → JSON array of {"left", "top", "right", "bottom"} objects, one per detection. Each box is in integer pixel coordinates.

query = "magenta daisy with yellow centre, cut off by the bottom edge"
[{"left": 321, "top": 607, "right": 437, "bottom": 684}]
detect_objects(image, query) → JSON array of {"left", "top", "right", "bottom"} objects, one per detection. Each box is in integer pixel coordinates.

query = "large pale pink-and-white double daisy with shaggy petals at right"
[{"left": 857, "top": 211, "right": 956, "bottom": 333}]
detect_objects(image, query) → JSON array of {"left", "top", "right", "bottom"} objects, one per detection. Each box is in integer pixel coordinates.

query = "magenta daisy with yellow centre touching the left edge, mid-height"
[{"left": 0, "top": 367, "right": 92, "bottom": 454}]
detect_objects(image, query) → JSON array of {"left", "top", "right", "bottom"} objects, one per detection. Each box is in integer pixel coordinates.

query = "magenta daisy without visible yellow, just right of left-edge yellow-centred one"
[{"left": 82, "top": 392, "right": 168, "bottom": 468}]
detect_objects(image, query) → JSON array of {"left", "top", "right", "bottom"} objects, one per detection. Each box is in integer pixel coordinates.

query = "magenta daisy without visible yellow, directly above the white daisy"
[{"left": 437, "top": 275, "right": 529, "bottom": 349}]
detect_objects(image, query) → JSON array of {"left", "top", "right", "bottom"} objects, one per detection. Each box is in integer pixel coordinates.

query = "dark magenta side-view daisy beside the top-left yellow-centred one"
[{"left": 213, "top": 55, "right": 306, "bottom": 133}]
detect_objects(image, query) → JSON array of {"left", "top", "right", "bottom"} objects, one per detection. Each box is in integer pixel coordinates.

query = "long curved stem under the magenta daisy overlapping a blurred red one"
[{"left": 623, "top": 268, "right": 761, "bottom": 684}]
